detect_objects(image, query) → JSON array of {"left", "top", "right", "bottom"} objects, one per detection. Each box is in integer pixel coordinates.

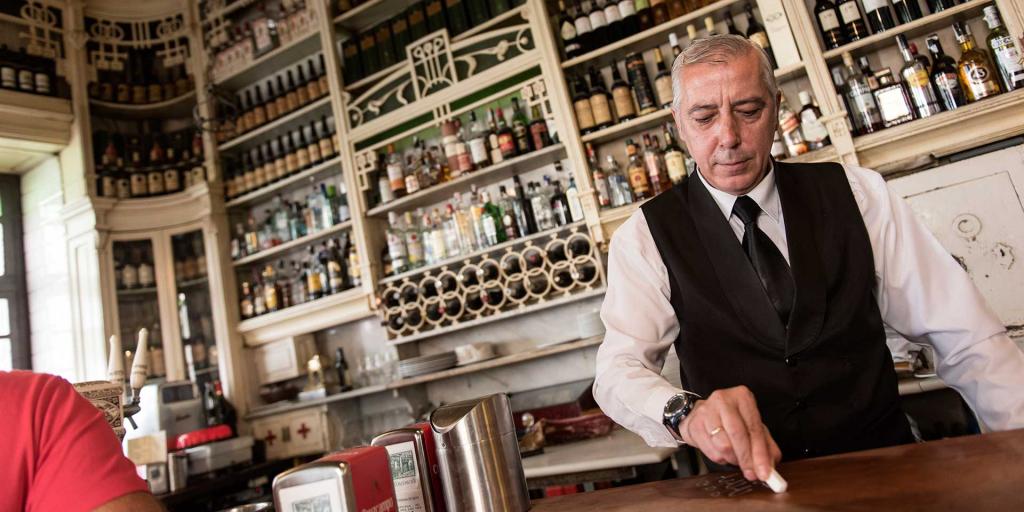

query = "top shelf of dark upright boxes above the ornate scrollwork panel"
[{"left": 335, "top": 0, "right": 523, "bottom": 91}]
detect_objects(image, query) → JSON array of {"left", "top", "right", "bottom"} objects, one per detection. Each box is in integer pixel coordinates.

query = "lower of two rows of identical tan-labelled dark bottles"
[{"left": 224, "top": 117, "right": 340, "bottom": 203}]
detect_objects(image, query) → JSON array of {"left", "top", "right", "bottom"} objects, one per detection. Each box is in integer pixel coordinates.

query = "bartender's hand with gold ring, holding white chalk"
[{"left": 679, "top": 386, "right": 782, "bottom": 481}]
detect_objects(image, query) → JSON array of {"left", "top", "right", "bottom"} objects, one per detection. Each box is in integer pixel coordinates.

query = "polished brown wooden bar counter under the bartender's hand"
[{"left": 530, "top": 429, "right": 1024, "bottom": 512}]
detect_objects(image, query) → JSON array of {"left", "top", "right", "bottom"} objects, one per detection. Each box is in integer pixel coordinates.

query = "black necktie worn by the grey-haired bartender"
[{"left": 732, "top": 196, "right": 796, "bottom": 326}]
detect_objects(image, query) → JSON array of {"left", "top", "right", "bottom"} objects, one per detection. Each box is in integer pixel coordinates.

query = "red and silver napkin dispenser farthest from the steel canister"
[{"left": 273, "top": 446, "right": 397, "bottom": 512}]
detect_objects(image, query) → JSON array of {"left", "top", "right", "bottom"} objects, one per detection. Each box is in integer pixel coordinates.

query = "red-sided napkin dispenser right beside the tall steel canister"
[{"left": 370, "top": 423, "right": 446, "bottom": 512}]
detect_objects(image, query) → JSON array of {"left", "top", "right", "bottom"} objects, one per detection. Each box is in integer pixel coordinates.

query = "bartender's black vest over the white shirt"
[{"left": 642, "top": 163, "right": 913, "bottom": 460}]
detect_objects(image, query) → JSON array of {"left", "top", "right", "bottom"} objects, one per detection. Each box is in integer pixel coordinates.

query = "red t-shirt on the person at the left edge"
[{"left": 0, "top": 372, "right": 148, "bottom": 512}]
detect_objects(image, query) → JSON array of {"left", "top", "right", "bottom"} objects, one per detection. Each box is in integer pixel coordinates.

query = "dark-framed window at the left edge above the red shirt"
[{"left": 0, "top": 174, "right": 32, "bottom": 370}]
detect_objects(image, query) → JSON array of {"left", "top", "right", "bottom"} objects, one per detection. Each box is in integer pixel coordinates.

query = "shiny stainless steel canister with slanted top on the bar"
[{"left": 430, "top": 393, "right": 529, "bottom": 512}]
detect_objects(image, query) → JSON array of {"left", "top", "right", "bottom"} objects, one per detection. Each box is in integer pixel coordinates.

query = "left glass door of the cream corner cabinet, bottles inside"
[{"left": 114, "top": 240, "right": 167, "bottom": 379}]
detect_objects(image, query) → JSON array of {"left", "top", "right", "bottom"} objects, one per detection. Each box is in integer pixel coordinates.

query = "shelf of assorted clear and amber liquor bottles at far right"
[{"left": 831, "top": 5, "right": 1024, "bottom": 155}]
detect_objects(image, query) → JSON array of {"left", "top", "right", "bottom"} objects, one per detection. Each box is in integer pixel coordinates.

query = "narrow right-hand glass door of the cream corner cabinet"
[{"left": 171, "top": 229, "right": 218, "bottom": 389}]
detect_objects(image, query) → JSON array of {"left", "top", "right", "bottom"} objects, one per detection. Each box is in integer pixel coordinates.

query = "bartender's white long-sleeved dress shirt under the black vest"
[{"left": 594, "top": 166, "right": 1024, "bottom": 446}]
